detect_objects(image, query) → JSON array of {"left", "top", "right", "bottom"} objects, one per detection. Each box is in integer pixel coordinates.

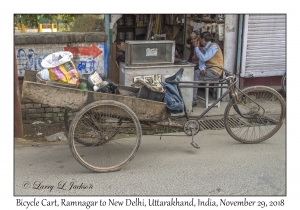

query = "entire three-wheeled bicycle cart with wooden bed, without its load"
[{"left": 22, "top": 68, "right": 285, "bottom": 172}]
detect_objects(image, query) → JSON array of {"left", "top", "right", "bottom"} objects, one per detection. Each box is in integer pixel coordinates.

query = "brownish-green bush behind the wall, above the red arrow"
[{"left": 70, "top": 15, "right": 105, "bottom": 32}]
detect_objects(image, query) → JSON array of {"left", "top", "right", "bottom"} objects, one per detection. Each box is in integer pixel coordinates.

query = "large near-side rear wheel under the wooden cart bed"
[{"left": 69, "top": 100, "right": 142, "bottom": 172}]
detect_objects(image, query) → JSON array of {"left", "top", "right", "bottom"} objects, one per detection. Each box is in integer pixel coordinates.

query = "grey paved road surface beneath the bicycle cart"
[{"left": 14, "top": 121, "right": 286, "bottom": 196}]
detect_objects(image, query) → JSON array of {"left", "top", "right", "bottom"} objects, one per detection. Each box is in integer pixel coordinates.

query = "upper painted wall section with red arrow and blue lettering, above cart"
[{"left": 15, "top": 32, "right": 107, "bottom": 76}]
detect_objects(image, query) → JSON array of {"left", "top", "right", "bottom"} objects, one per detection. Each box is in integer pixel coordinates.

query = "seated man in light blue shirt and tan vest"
[{"left": 193, "top": 33, "right": 224, "bottom": 106}]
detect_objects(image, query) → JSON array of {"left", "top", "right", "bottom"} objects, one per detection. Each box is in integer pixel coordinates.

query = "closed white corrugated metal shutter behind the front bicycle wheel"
[{"left": 241, "top": 14, "right": 286, "bottom": 77}]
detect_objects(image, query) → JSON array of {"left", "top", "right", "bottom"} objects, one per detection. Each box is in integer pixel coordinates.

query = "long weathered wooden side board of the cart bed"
[{"left": 22, "top": 78, "right": 169, "bottom": 122}]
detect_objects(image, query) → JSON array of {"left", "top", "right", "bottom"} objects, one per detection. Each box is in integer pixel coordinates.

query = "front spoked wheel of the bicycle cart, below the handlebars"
[{"left": 224, "top": 86, "right": 285, "bottom": 143}]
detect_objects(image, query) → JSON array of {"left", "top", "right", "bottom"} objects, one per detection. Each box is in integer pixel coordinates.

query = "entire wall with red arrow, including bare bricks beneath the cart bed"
[{"left": 14, "top": 32, "right": 107, "bottom": 123}]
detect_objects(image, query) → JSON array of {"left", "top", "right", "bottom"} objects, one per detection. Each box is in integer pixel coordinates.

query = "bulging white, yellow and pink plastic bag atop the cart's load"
[{"left": 41, "top": 51, "right": 79, "bottom": 84}]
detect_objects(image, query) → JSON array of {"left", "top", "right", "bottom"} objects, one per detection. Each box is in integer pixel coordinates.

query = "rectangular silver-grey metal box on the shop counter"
[{"left": 125, "top": 40, "right": 175, "bottom": 66}]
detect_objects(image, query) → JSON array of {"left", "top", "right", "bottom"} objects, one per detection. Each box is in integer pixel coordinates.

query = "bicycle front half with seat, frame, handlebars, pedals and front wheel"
[{"left": 161, "top": 66, "right": 284, "bottom": 149}]
